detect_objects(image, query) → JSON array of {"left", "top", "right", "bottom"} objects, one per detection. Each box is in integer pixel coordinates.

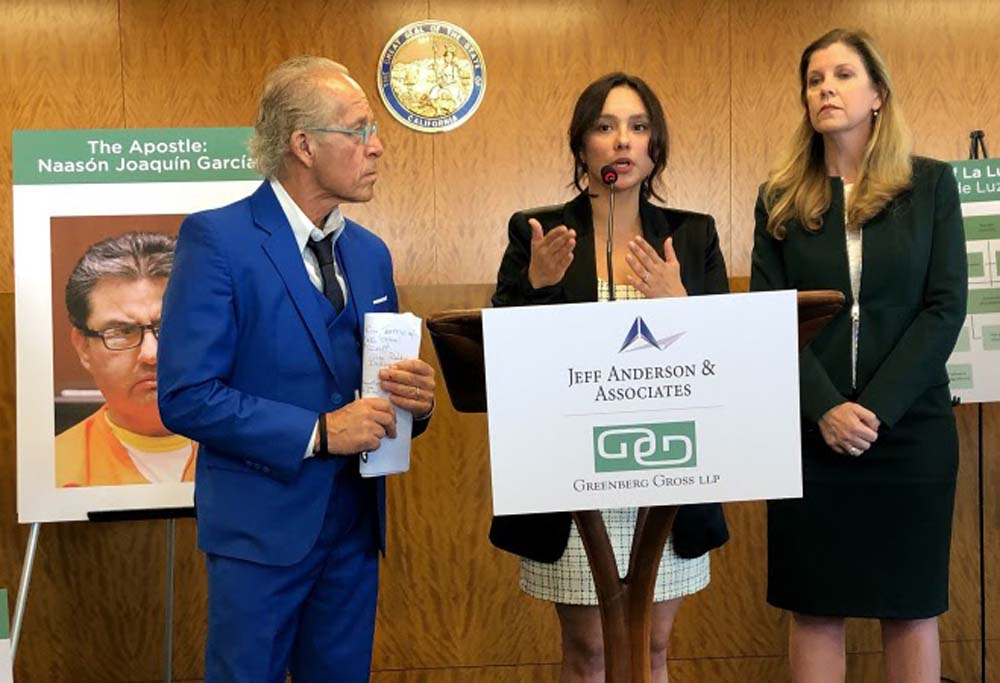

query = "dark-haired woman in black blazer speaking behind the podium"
[{"left": 490, "top": 73, "right": 729, "bottom": 682}]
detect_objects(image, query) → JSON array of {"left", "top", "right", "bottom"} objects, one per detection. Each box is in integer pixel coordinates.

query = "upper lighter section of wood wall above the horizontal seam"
[{"left": 0, "top": 0, "right": 1000, "bottom": 292}]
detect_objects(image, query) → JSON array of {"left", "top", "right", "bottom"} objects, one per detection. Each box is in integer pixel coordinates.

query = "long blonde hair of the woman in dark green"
[{"left": 764, "top": 29, "right": 913, "bottom": 239}]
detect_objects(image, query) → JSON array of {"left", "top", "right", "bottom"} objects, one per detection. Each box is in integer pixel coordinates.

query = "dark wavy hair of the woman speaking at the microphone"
[{"left": 569, "top": 71, "right": 670, "bottom": 201}]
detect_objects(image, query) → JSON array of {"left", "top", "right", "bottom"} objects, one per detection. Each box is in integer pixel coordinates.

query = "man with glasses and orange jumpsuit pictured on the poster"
[{"left": 56, "top": 232, "right": 197, "bottom": 487}]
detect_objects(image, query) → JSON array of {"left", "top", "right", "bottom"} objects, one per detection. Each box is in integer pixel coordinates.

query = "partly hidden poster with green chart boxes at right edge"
[{"left": 948, "top": 159, "right": 1000, "bottom": 403}]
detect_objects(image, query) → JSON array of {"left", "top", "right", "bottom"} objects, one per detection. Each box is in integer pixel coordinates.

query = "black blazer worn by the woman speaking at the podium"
[{"left": 490, "top": 193, "right": 729, "bottom": 562}]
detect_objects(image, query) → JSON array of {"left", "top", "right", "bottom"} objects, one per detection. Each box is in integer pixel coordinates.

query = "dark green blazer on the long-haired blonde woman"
[{"left": 750, "top": 157, "right": 968, "bottom": 429}]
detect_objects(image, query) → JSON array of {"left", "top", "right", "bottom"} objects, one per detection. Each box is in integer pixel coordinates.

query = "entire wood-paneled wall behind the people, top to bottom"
[{"left": 0, "top": 0, "right": 1000, "bottom": 683}]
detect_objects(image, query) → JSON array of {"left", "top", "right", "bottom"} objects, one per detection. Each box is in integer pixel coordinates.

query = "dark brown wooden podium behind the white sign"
[{"left": 427, "top": 290, "right": 844, "bottom": 683}]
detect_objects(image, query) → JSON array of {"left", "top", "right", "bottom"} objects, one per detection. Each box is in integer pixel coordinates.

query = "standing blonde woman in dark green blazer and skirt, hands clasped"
[{"left": 750, "top": 30, "right": 967, "bottom": 681}]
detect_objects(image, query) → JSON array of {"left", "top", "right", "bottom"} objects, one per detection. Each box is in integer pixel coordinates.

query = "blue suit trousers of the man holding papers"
[{"left": 205, "top": 470, "right": 379, "bottom": 683}]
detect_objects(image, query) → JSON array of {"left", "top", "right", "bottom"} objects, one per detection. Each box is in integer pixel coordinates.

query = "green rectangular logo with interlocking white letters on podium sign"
[{"left": 594, "top": 420, "right": 698, "bottom": 472}]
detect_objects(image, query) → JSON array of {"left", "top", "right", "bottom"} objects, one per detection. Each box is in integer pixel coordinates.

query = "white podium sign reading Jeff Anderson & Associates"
[{"left": 482, "top": 291, "right": 802, "bottom": 515}]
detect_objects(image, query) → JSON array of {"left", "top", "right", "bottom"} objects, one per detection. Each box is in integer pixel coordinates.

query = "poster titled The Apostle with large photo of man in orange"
[{"left": 13, "top": 128, "right": 260, "bottom": 523}]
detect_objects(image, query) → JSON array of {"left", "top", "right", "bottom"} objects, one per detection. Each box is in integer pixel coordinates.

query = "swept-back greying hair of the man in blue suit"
[{"left": 250, "top": 55, "right": 350, "bottom": 178}]
